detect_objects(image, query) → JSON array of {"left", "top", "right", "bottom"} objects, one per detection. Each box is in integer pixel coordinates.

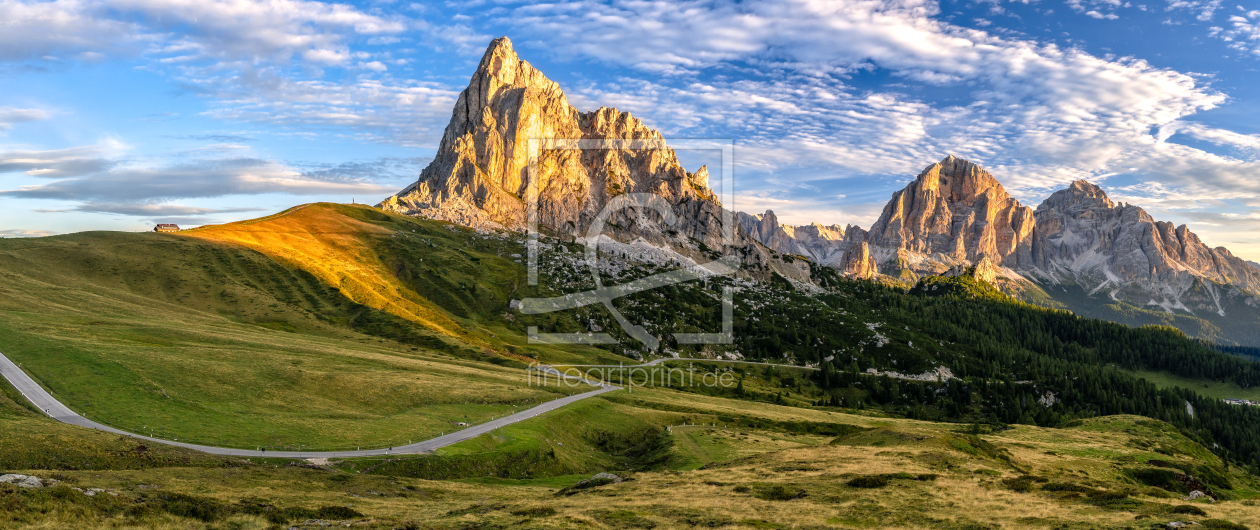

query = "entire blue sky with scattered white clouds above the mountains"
[{"left": 0, "top": 0, "right": 1260, "bottom": 261}]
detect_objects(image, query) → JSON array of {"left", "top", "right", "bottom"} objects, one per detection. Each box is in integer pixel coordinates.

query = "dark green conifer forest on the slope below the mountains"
[{"left": 575, "top": 267, "right": 1260, "bottom": 472}]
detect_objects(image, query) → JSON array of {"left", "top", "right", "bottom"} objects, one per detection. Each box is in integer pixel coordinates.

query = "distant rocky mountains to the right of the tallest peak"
[{"left": 740, "top": 156, "right": 1260, "bottom": 344}]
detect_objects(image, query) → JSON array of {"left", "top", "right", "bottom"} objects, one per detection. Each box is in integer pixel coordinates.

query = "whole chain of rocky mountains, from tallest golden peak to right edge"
[{"left": 379, "top": 38, "right": 1260, "bottom": 346}]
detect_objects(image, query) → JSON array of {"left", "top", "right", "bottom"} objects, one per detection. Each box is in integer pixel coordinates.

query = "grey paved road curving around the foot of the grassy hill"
[{"left": 0, "top": 354, "right": 620, "bottom": 458}]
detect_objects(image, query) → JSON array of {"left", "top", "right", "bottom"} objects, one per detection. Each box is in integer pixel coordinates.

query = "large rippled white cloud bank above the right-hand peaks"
[{"left": 517, "top": 0, "right": 1225, "bottom": 176}]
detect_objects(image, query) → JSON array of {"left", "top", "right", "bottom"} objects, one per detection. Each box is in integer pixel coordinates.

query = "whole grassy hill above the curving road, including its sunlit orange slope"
[{"left": 0, "top": 204, "right": 627, "bottom": 448}]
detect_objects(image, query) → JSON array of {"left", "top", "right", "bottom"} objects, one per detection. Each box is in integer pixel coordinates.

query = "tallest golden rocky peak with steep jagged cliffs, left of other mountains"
[{"left": 378, "top": 37, "right": 809, "bottom": 281}]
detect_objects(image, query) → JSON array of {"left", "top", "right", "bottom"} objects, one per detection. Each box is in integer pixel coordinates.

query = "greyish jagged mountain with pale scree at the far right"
[{"left": 1036, "top": 180, "right": 1260, "bottom": 312}]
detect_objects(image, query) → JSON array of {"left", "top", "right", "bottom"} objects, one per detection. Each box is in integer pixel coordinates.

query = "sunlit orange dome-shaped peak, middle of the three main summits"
[{"left": 867, "top": 155, "right": 1040, "bottom": 272}]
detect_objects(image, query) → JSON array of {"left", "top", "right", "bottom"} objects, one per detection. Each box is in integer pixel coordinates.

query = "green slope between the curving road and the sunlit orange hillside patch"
[{"left": 0, "top": 221, "right": 584, "bottom": 448}]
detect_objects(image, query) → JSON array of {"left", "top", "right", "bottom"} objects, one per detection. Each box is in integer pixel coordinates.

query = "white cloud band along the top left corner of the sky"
[{"left": 0, "top": 0, "right": 407, "bottom": 64}]
